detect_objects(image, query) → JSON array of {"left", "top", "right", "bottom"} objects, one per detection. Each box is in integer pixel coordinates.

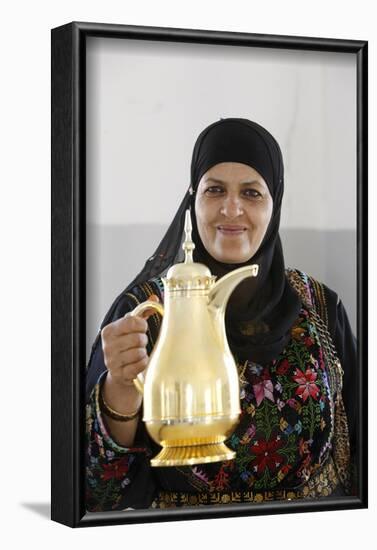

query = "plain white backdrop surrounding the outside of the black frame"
[{"left": 0, "top": 0, "right": 377, "bottom": 550}]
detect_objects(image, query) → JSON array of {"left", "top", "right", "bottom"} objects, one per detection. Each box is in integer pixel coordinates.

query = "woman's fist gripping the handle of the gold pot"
[{"left": 101, "top": 294, "right": 159, "bottom": 387}]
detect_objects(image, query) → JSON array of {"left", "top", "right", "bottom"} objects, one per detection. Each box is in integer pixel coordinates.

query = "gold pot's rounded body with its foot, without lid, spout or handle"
[{"left": 143, "top": 290, "right": 240, "bottom": 466}]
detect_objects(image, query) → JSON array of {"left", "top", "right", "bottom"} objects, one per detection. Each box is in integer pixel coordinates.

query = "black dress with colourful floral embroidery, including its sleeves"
[{"left": 86, "top": 270, "right": 357, "bottom": 512}]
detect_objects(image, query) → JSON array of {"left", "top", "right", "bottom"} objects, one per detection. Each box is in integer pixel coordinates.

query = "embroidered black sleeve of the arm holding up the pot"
[{"left": 86, "top": 280, "right": 163, "bottom": 512}]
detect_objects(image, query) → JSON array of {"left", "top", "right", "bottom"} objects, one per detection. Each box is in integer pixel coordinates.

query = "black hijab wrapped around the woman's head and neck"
[{"left": 122, "top": 118, "right": 301, "bottom": 364}]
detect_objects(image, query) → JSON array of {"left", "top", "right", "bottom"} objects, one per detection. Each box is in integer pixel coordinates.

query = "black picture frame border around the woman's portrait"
[{"left": 51, "top": 22, "right": 368, "bottom": 527}]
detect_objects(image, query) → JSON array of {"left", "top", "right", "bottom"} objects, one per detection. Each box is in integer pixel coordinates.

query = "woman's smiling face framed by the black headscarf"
[{"left": 195, "top": 162, "right": 273, "bottom": 263}]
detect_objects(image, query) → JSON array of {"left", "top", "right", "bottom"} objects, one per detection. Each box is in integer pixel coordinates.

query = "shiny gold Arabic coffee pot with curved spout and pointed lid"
[{"left": 129, "top": 210, "right": 258, "bottom": 466}]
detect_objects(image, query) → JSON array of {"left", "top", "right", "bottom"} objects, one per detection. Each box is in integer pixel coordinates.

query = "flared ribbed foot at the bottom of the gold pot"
[{"left": 151, "top": 443, "right": 236, "bottom": 466}]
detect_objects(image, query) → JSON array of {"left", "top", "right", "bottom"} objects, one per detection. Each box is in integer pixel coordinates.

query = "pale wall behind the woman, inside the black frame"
[{"left": 87, "top": 38, "right": 356, "bottom": 353}]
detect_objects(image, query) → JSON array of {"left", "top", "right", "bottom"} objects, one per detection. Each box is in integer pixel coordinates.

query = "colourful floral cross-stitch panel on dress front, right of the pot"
[{"left": 188, "top": 309, "right": 331, "bottom": 491}]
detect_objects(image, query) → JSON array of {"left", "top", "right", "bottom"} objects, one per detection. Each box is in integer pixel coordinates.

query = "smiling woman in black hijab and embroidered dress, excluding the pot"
[{"left": 86, "top": 118, "right": 357, "bottom": 511}]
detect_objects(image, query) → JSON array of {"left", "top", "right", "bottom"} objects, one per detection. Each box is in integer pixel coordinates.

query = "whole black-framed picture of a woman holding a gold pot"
[{"left": 51, "top": 22, "right": 368, "bottom": 527}]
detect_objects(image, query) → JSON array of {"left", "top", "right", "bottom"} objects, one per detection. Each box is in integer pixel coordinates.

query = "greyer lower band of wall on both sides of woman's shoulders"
[{"left": 86, "top": 224, "right": 356, "bottom": 357}]
